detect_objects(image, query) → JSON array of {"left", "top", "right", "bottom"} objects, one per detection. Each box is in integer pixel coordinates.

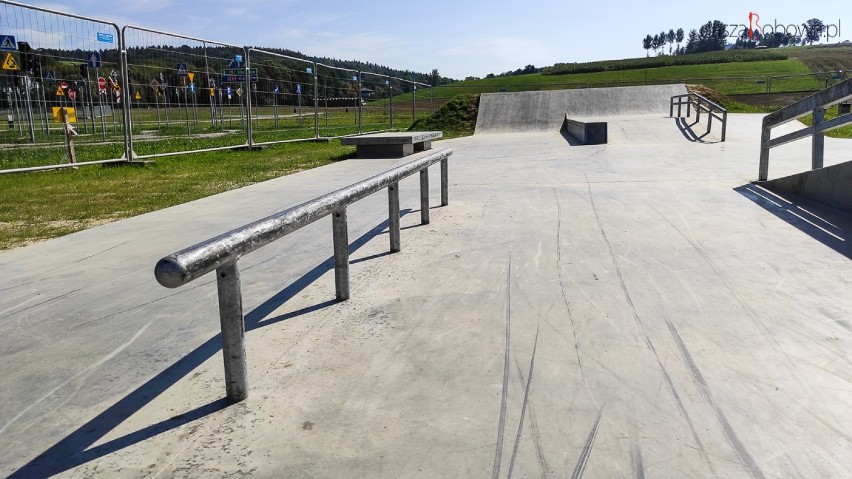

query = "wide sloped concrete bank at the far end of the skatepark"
[{"left": 476, "top": 85, "right": 687, "bottom": 134}]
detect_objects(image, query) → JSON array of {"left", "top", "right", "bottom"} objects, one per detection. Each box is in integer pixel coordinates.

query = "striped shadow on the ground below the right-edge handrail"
[{"left": 734, "top": 183, "right": 852, "bottom": 259}]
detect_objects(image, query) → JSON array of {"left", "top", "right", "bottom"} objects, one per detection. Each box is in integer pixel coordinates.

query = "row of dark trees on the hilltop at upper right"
[{"left": 642, "top": 18, "right": 826, "bottom": 57}]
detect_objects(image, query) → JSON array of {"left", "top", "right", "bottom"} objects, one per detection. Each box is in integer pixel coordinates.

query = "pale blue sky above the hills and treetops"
[{"left": 13, "top": 0, "right": 852, "bottom": 79}]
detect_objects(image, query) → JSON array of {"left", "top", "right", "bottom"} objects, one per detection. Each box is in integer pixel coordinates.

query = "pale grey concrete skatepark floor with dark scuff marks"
[{"left": 0, "top": 95, "right": 852, "bottom": 478}]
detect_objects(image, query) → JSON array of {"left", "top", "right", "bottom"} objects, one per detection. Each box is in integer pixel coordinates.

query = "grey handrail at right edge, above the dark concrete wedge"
[{"left": 757, "top": 78, "right": 852, "bottom": 181}]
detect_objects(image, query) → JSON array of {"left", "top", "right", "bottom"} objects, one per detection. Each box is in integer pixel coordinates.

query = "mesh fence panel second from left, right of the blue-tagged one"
[{"left": 122, "top": 26, "right": 252, "bottom": 158}]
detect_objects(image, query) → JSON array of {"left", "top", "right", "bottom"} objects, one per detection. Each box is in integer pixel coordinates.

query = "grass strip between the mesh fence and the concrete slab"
[{"left": 0, "top": 141, "right": 354, "bottom": 249}]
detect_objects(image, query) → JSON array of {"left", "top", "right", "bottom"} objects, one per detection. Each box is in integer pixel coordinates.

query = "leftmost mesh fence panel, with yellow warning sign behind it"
[{"left": 0, "top": 1, "right": 125, "bottom": 170}]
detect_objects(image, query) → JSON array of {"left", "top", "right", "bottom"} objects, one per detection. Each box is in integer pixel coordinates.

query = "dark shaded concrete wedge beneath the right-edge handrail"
[{"left": 762, "top": 161, "right": 852, "bottom": 212}]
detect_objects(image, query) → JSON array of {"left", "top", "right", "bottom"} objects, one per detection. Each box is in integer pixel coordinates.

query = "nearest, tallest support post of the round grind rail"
[{"left": 216, "top": 261, "right": 248, "bottom": 403}]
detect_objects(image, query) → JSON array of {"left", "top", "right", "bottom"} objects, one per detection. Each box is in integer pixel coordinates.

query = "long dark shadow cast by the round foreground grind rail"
[{"left": 9, "top": 209, "right": 411, "bottom": 479}]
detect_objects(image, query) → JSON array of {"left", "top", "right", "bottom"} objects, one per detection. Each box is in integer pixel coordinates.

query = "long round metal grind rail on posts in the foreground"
[{"left": 154, "top": 148, "right": 453, "bottom": 403}]
